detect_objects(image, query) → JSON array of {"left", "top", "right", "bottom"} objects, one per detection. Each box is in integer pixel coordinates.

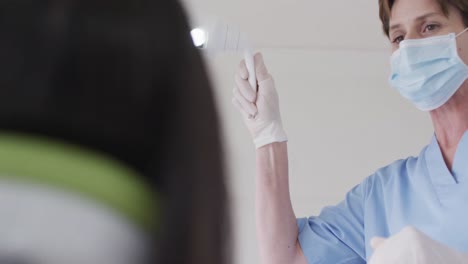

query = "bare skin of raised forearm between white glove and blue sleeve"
[{"left": 256, "top": 142, "right": 302, "bottom": 264}]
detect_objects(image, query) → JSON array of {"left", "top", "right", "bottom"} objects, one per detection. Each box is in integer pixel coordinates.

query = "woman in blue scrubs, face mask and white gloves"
[{"left": 233, "top": 0, "right": 468, "bottom": 264}]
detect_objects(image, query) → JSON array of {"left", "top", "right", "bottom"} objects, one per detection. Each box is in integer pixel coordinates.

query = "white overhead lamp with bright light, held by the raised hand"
[{"left": 191, "top": 21, "right": 257, "bottom": 99}]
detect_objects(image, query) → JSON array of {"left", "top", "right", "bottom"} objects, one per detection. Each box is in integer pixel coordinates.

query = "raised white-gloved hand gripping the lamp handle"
[{"left": 232, "top": 53, "right": 287, "bottom": 148}]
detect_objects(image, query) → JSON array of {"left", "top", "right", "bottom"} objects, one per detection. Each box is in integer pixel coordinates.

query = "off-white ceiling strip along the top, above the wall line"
[{"left": 182, "top": 0, "right": 388, "bottom": 50}]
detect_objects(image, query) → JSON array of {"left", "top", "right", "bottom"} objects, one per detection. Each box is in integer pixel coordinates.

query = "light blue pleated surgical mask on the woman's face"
[{"left": 390, "top": 28, "right": 468, "bottom": 111}]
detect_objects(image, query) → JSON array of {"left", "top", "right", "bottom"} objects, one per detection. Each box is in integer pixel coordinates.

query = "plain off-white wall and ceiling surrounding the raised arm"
[{"left": 185, "top": 0, "right": 432, "bottom": 264}]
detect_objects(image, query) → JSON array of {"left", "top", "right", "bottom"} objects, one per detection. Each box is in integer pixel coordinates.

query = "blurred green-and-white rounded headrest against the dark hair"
[{"left": 0, "top": 133, "right": 156, "bottom": 264}]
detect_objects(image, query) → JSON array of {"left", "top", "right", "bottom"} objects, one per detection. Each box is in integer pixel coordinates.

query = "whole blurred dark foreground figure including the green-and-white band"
[{"left": 0, "top": 0, "right": 229, "bottom": 264}]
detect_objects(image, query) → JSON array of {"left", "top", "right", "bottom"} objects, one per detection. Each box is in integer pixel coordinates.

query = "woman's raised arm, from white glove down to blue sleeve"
[{"left": 233, "top": 54, "right": 307, "bottom": 264}]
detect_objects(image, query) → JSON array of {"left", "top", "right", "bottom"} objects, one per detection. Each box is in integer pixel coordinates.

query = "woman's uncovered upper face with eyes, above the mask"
[{"left": 389, "top": 0, "right": 468, "bottom": 64}]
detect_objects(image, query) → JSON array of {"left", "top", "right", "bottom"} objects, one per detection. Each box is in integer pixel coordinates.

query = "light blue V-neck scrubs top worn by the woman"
[{"left": 297, "top": 131, "right": 468, "bottom": 264}]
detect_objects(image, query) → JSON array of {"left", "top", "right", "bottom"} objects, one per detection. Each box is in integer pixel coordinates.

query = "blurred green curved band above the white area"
[{"left": 0, "top": 133, "right": 159, "bottom": 231}]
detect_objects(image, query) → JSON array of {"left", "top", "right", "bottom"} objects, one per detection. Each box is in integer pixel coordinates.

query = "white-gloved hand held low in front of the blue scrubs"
[{"left": 369, "top": 227, "right": 468, "bottom": 264}]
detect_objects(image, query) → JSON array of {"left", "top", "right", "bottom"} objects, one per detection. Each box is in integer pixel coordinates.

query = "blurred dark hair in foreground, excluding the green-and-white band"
[{"left": 0, "top": 0, "right": 229, "bottom": 264}]
